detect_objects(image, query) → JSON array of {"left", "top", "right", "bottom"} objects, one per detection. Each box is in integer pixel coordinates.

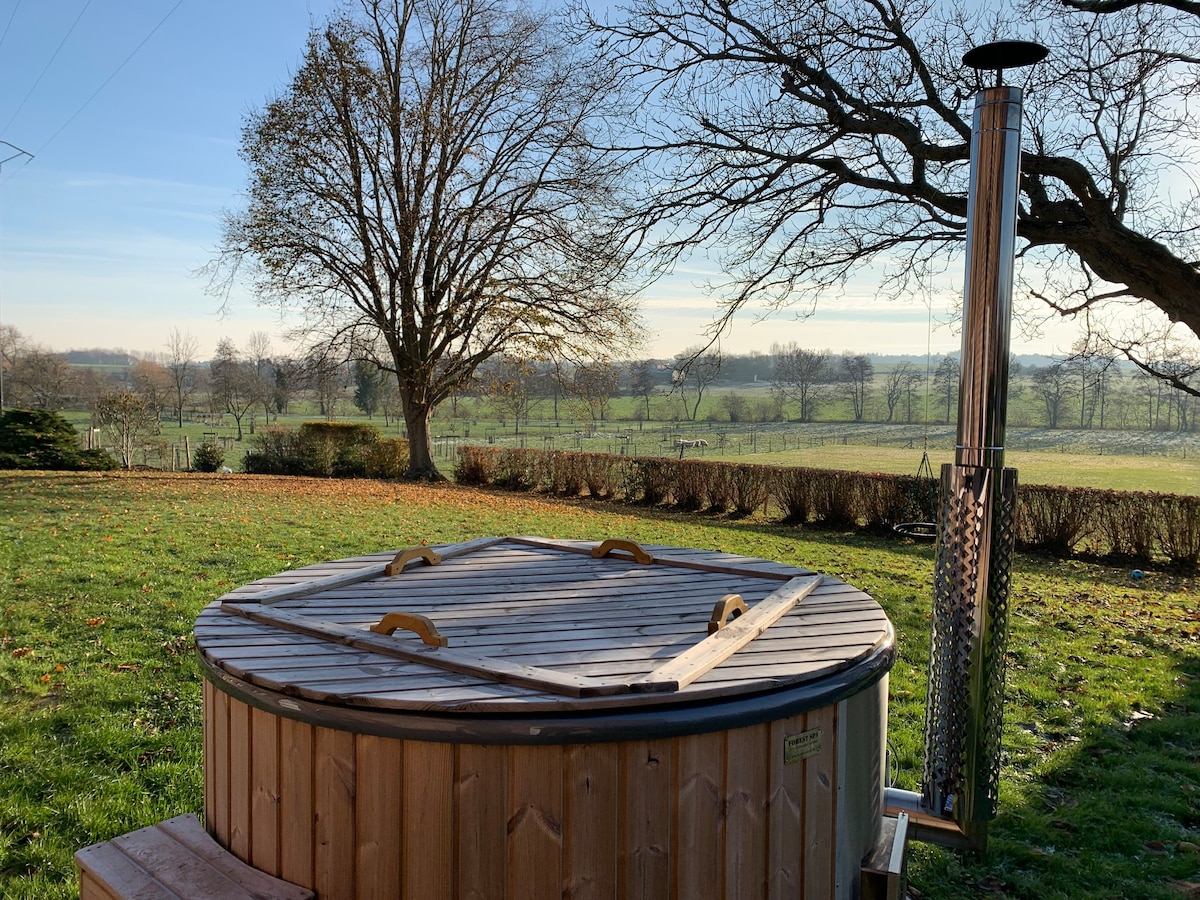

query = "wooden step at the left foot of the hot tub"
[{"left": 74, "top": 814, "right": 316, "bottom": 900}]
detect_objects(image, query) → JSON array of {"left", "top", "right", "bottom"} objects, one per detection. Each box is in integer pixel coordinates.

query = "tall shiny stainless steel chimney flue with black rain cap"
[{"left": 920, "top": 41, "right": 1045, "bottom": 848}]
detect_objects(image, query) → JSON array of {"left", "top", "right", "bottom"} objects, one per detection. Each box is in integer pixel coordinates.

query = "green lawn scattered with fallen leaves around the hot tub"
[{"left": 0, "top": 473, "right": 1200, "bottom": 900}]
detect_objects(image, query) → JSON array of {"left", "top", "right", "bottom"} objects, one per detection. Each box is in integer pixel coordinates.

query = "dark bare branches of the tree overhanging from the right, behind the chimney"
[{"left": 592, "top": 0, "right": 1200, "bottom": 381}]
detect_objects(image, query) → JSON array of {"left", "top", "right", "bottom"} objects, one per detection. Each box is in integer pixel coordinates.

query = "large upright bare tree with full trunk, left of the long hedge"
[{"left": 215, "top": 0, "right": 648, "bottom": 479}]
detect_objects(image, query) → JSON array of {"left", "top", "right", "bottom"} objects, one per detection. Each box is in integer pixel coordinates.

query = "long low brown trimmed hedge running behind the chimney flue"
[{"left": 455, "top": 446, "right": 1200, "bottom": 569}]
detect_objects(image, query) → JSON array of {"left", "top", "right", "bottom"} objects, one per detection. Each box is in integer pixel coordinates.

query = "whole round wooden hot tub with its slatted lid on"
[{"left": 196, "top": 538, "right": 894, "bottom": 900}]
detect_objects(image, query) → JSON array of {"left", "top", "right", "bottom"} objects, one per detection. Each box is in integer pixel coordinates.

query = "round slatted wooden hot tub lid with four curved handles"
[{"left": 196, "top": 538, "right": 893, "bottom": 714}]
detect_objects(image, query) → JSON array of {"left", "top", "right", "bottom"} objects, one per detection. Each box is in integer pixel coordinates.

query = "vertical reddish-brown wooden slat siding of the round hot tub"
[{"left": 205, "top": 691, "right": 838, "bottom": 900}]
